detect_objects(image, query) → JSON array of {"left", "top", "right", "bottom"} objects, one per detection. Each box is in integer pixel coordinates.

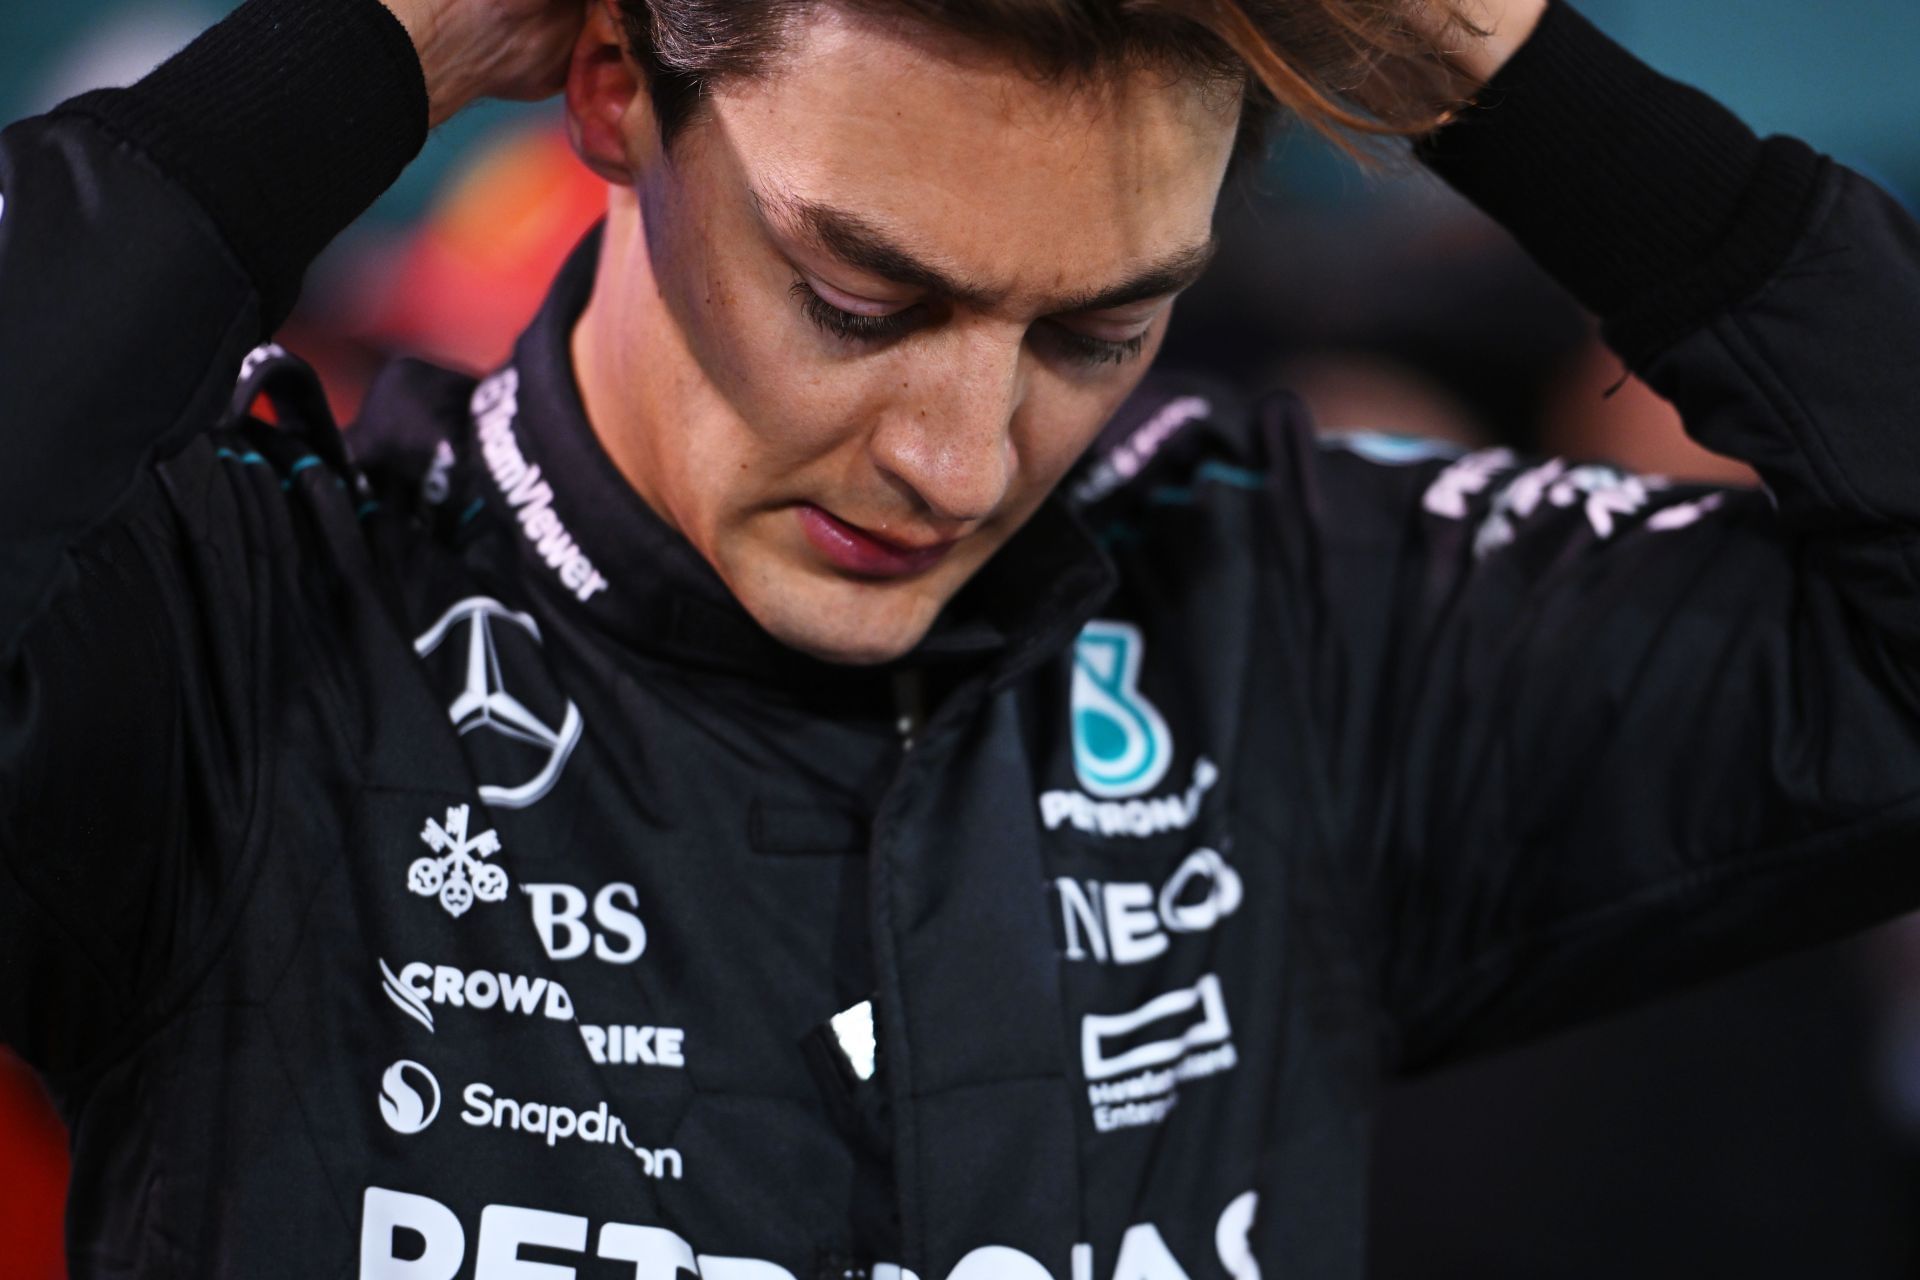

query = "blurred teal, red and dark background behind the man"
[{"left": 0, "top": 0, "right": 1920, "bottom": 1280}]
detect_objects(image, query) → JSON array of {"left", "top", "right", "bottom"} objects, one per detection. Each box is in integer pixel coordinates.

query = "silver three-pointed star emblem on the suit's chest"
[{"left": 413, "top": 595, "right": 582, "bottom": 808}]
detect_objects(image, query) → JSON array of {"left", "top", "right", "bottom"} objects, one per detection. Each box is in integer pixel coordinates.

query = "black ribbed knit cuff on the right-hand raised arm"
[{"left": 1419, "top": 0, "right": 1826, "bottom": 365}]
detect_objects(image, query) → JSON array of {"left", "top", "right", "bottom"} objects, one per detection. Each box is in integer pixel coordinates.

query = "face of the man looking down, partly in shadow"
[{"left": 574, "top": 6, "right": 1238, "bottom": 662}]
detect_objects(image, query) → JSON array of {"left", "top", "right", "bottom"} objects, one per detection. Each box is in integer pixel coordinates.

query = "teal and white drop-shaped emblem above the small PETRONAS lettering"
[{"left": 1071, "top": 620, "right": 1173, "bottom": 800}]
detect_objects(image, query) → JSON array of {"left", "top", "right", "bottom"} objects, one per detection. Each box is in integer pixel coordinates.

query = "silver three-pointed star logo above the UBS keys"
[{"left": 413, "top": 595, "right": 582, "bottom": 808}]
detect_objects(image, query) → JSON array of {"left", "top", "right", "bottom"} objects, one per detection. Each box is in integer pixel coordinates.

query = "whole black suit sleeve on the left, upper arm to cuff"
[{"left": 0, "top": 0, "right": 426, "bottom": 1065}]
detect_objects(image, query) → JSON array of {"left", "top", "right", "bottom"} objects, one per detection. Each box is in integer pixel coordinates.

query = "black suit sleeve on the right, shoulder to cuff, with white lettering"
[{"left": 1290, "top": 4, "right": 1920, "bottom": 1067}]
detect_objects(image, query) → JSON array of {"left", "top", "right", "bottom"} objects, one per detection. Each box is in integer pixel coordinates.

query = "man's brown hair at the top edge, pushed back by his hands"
[{"left": 616, "top": 0, "right": 1475, "bottom": 154}]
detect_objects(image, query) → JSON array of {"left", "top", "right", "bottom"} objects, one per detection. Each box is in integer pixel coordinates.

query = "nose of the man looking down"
[{"left": 870, "top": 338, "right": 1023, "bottom": 533}]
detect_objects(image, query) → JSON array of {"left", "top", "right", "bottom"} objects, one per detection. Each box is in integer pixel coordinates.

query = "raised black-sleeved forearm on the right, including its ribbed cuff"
[{"left": 1425, "top": 6, "right": 1920, "bottom": 621}]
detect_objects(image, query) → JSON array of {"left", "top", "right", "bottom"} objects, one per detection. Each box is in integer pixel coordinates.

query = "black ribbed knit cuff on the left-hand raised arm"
[{"left": 54, "top": 0, "right": 426, "bottom": 330}]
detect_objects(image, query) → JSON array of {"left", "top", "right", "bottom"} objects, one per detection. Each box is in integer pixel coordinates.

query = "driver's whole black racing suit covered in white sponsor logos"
[{"left": 0, "top": 0, "right": 1920, "bottom": 1280}]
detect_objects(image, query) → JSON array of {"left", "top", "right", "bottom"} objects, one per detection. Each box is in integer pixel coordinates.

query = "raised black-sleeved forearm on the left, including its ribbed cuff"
[{"left": 0, "top": 0, "right": 426, "bottom": 652}]
